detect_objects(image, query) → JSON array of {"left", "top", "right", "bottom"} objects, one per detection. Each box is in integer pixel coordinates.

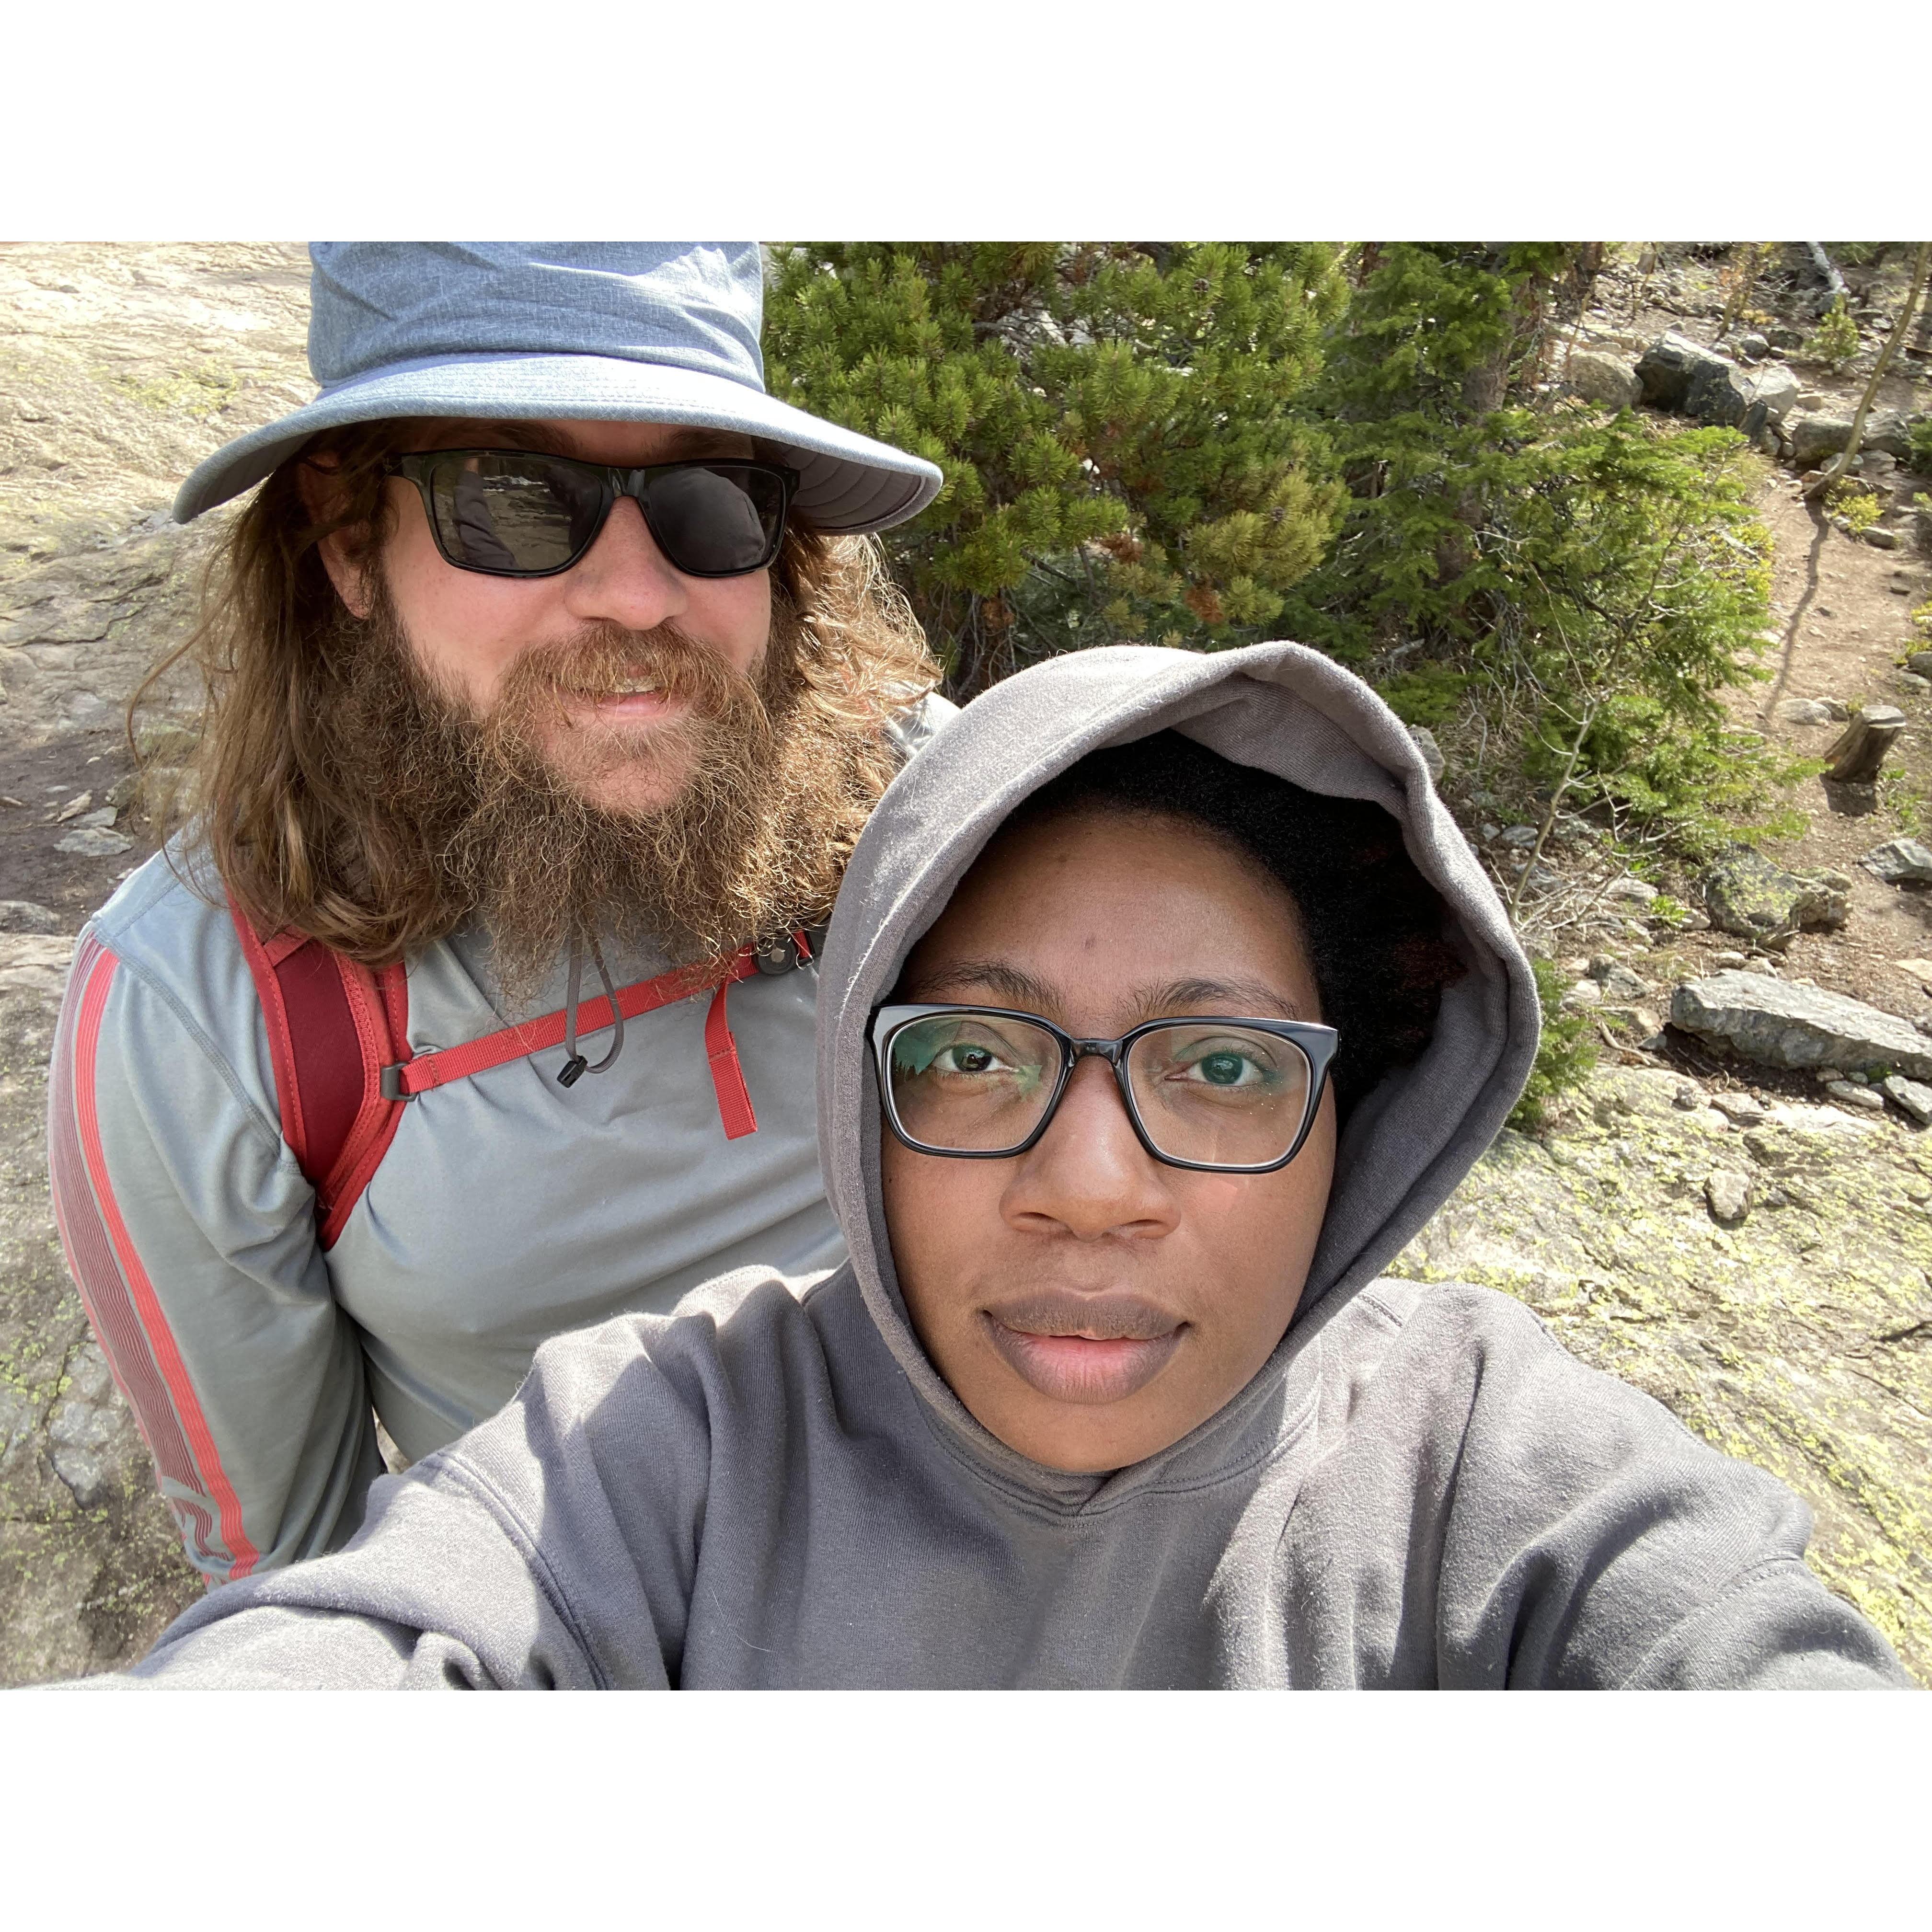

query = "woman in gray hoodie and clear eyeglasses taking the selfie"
[{"left": 83, "top": 645, "right": 1907, "bottom": 1687}]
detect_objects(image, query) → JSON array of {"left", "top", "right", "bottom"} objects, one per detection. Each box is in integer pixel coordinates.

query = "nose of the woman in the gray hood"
[{"left": 1001, "top": 1055, "right": 1181, "bottom": 1241}]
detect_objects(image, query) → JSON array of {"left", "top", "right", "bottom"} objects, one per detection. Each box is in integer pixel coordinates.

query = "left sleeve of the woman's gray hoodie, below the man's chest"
[{"left": 85, "top": 1318, "right": 715, "bottom": 1690}]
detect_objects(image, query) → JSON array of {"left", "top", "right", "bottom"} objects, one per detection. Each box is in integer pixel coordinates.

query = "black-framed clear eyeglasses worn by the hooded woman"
[{"left": 871, "top": 1005, "right": 1337, "bottom": 1174}]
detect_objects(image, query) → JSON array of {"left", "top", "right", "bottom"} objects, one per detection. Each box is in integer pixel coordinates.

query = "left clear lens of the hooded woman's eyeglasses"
[{"left": 885, "top": 1012, "right": 1061, "bottom": 1153}]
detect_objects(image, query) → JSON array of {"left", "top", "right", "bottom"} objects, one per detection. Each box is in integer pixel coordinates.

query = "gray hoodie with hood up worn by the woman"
[{"left": 98, "top": 645, "right": 1907, "bottom": 1687}]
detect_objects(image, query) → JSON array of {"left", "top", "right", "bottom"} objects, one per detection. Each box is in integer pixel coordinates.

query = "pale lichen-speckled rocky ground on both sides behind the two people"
[{"left": 0, "top": 243, "right": 1932, "bottom": 1685}]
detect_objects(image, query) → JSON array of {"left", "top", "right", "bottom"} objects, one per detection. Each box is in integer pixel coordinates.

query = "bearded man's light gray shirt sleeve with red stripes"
[{"left": 48, "top": 929, "right": 382, "bottom": 1582}]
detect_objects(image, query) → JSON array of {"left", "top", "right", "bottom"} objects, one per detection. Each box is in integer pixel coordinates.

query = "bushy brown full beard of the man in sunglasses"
[{"left": 333, "top": 586, "right": 895, "bottom": 1005}]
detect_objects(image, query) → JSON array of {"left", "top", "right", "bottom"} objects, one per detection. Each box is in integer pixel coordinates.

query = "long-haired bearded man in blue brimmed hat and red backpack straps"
[{"left": 50, "top": 243, "right": 951, "bottom": 1580}]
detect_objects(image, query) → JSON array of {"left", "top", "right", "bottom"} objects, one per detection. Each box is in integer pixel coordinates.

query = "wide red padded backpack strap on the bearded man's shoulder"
[{"left": 228, "top": 902, "right": 410, "bottom": 1250}]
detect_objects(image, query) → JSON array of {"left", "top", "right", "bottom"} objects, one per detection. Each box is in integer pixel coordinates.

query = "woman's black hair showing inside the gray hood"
[{"left": 1007, "top": 730, "right": 1466, "bottom": 1119}]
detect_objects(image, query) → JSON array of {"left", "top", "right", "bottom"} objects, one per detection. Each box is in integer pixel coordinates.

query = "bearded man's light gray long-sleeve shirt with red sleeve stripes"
[{"left": 48, "top": 698, "right": 954, "bottom": 1580}]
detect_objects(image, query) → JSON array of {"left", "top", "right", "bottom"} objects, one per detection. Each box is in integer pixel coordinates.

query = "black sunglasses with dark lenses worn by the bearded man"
[{"left": 384, "top": 450, "right": 798, "bottom": 578}]
